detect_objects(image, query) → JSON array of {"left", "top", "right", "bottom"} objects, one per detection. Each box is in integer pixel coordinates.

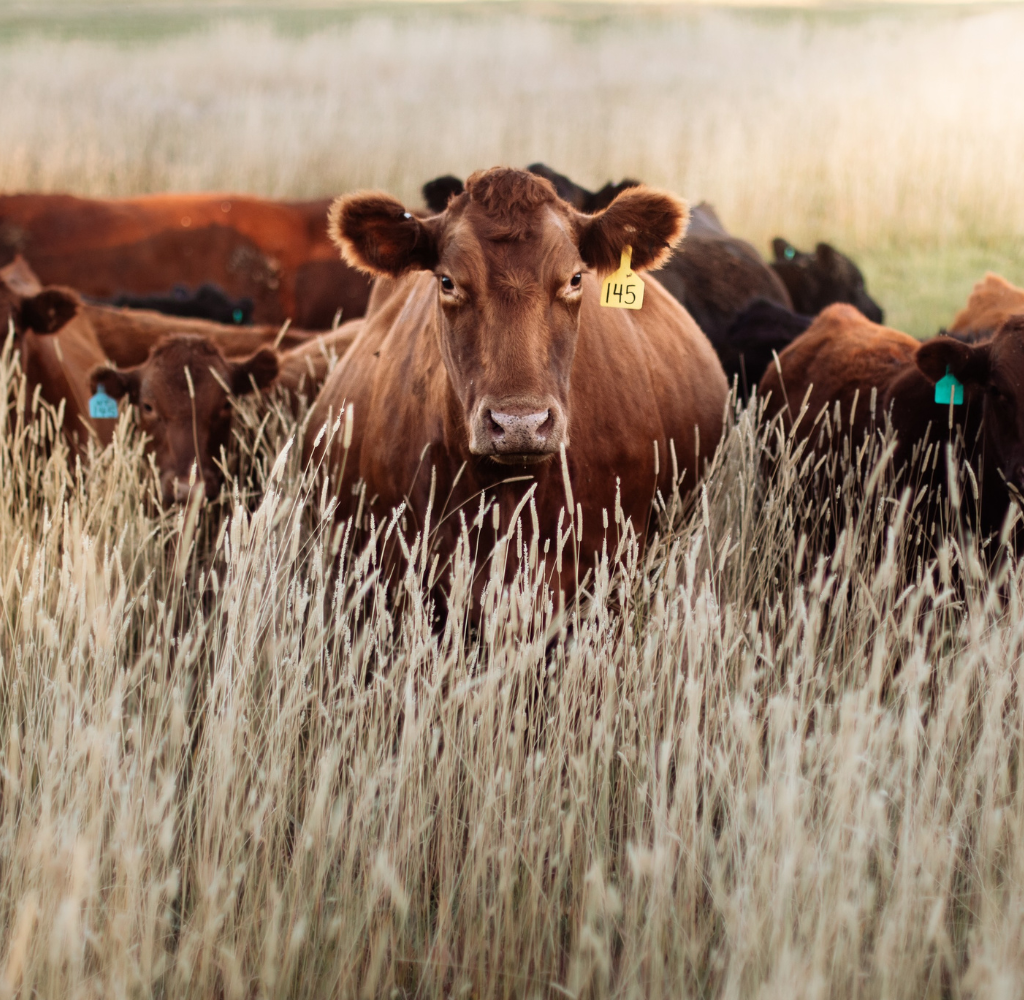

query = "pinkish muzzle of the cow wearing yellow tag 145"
[{"left": 469, "top": 398, "right": 569, "bottom": 465}]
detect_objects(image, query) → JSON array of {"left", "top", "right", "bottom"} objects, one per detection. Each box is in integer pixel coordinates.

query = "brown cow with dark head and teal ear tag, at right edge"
[{"left": 760, "top": 305, "right": 1024, "bottom": 530}]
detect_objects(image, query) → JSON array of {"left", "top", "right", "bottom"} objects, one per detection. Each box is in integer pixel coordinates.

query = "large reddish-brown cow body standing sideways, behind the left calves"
[{"left": 0, "top": 194, "right": 370, "bottom": 330}]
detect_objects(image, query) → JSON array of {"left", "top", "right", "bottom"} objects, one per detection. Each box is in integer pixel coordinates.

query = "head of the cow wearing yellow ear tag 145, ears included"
[{"left": 330, "top": 168, "right": 687, "bottom": 465}]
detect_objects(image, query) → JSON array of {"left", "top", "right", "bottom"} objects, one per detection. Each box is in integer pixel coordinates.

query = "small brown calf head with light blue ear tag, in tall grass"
[{"left": 89, "top": 334, "right": 278, "bottom": 505}]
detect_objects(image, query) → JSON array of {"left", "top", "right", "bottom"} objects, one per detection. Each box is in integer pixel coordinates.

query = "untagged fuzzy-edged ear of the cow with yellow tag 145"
[{"left": 328, "top": 191, "right": 437, "bottom": 277}]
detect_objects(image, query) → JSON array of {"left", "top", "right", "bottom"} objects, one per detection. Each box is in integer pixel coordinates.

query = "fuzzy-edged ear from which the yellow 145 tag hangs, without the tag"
[{"left": 577, "top": 185, "right": 690, "bottom": 274}]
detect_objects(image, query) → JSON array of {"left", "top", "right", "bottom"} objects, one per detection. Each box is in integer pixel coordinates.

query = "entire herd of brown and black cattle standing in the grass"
[{"left": 0, "top": 164, "right": 1024, "bottom": 590}]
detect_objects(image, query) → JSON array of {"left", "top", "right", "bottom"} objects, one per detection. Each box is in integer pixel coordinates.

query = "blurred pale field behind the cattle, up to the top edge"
[{"left": 0, "top": 2, "right": 1024, "bottom": 336}]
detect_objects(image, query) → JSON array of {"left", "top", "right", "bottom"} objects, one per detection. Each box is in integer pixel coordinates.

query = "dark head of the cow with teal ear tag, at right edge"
[{"left": 916, "top": 316, "right": 1024, "bottom": 491}]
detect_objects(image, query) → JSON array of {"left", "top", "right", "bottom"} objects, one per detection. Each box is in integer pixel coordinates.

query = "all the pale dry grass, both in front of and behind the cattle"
[{"left": 0, "top": 7, "right": 1024, "bottom": 1000}]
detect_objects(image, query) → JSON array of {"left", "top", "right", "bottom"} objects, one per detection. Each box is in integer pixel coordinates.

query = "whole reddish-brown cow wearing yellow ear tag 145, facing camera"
[{"left": 304, "top": 168, "right": 728, "bottom": 590}]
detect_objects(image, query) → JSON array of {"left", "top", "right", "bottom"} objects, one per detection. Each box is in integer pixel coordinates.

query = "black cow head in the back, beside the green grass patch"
[{"left": 771, "top": 236, "right": 884, "bottom": 323}]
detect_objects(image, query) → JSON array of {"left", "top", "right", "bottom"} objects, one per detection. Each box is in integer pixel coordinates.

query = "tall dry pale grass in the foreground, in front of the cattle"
[{"left": 0, "top": 323, "right": 1024, "bottom": 1000}]
